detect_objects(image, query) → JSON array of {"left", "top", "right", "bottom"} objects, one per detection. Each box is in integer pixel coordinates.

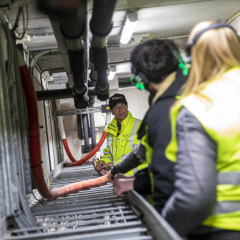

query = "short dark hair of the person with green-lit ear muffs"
[{"left": 131, "top": 39, "right": 179, "bottom": 83}]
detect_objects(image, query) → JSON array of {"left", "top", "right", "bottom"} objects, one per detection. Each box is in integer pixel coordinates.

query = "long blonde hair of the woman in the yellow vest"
[{"left": 182, "top": 21, "right": 240, "bottom": 97}]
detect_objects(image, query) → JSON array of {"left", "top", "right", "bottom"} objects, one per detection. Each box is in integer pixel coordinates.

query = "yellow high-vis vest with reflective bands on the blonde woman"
[{"left": 166, "top": 68, "right": 240, "bottom": 231}]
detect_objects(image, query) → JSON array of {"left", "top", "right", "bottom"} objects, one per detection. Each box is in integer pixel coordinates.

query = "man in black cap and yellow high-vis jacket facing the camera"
[{"left": 96, "top": 93, "right": 147, "bottom": 175}]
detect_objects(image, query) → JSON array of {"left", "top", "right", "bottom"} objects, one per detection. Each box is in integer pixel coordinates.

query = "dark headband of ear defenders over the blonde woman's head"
[{"left": 185, "top": 22, "right": 238, "bottom": 59}]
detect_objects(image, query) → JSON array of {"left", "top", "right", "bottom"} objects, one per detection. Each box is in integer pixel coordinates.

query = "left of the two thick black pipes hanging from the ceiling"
[{"left": 39, "top": 0, "right": 88, "bottom": 97}]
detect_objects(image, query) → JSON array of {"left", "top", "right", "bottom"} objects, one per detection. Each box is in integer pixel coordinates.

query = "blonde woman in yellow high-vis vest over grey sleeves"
[{"left": 162, "top": 21, "right": 240, "bottom": 240}]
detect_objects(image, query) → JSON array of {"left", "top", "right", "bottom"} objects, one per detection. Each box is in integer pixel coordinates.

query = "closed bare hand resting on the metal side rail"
[{"left": 113, "top": 174, "right": 135, "bottom": 197}]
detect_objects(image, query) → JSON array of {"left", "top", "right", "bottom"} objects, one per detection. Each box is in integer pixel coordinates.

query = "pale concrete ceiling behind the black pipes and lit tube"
[{"left": 5, "top": 0, "right": 240, "bottom": 78}]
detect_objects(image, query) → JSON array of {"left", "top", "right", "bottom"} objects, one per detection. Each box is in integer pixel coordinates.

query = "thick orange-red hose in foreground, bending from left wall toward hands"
[{"left": 18, "top": 51, "right": 108, "bottom": 200}]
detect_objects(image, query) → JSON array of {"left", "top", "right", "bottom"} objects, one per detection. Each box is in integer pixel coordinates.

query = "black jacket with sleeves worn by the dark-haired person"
[{"left": 112, "top": 69, "right": 186, "bottom": 213}]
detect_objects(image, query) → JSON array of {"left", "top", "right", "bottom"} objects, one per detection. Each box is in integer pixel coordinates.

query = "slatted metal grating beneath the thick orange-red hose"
[{"left": 8, "top": 164, "right": 154, "bottom": 240}]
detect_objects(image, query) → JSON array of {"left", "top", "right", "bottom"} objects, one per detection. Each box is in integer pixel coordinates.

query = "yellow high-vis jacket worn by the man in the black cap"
[{"left": 100, "top": 112, "right": 148, "bottom": 175}]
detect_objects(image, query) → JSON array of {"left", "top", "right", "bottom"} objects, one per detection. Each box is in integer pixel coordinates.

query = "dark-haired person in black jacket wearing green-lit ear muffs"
[{"left": 109, "top": 39, "right": 187, "bottom": 213}]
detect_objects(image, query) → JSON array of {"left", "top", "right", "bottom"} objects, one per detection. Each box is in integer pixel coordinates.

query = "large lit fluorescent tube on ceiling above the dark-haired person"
[{"left": 120, "top": 12, "right": 138, "bottom": 44}]
